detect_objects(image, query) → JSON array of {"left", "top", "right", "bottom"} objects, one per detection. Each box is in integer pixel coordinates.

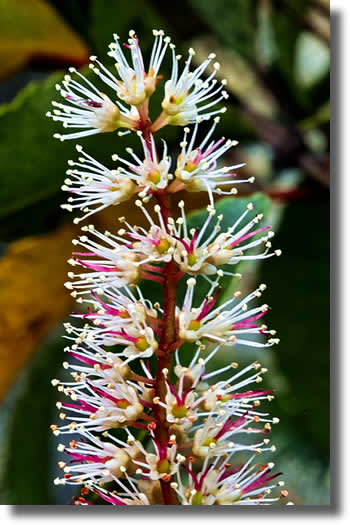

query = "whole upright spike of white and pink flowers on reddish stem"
[{"left": 48, "top": 30, "right": 288, "bottom": 505}]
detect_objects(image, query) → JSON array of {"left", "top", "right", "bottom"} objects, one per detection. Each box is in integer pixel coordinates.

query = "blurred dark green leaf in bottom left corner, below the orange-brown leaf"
[{"left": 0, "top": 328, "right": 63, "bottom": 505}]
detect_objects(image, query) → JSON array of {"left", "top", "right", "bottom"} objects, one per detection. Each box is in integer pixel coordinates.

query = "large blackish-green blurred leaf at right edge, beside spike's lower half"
[{"left": 259, "top": 200, "right": 330, "bottom": 456}]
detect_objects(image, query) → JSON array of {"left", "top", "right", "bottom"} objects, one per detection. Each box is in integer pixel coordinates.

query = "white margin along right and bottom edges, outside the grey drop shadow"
[{"left": 0, "top": 0, "right": 344, "bottom": 525}]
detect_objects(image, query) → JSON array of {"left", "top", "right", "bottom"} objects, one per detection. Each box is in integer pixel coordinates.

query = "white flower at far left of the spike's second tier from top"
[{"left": 61, "top": 146, "right": 137, "bottom": 224}]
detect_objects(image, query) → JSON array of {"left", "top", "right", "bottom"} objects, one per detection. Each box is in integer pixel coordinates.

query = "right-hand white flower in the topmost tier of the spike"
[{"left": 152, "top": 45, "right": 228, "bottom": 131}]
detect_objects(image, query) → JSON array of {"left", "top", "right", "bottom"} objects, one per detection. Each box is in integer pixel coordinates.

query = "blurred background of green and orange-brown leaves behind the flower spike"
[{"left": 0, "top": 0, "right": 330, "bottom": 505}]
